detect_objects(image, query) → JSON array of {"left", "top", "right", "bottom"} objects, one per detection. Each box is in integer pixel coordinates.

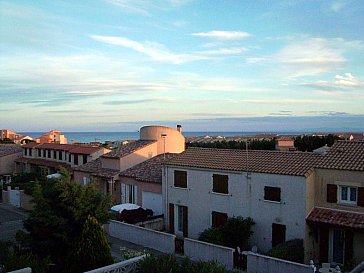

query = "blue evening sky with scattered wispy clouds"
[{"left": 0, "top": 0, "right": 364, "bottom": 132}]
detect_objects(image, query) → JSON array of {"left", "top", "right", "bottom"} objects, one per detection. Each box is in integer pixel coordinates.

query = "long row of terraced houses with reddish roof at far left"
[{"left": 15, "top": 142, "right": 110, "bottom": 175}]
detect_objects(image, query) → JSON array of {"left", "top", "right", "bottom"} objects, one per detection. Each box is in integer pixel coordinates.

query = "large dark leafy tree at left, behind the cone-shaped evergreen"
[{"left": 24, "top": 169, "right": 111, "bottom": 272}]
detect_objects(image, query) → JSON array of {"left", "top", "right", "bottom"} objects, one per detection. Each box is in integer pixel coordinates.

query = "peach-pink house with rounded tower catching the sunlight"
[{"left": 74, "top": 126, "right": 185, "bottom": 203}]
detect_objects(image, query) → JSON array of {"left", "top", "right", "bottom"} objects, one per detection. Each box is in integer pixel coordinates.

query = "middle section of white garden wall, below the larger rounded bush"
[{"left": 184, "top": 238, "right": 234, "bottom": 269}]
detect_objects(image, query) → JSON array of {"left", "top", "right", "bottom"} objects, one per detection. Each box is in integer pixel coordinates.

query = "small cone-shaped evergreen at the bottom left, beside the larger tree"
[{"left": 66, "top": 216, "right": 113, "bottom": 273}]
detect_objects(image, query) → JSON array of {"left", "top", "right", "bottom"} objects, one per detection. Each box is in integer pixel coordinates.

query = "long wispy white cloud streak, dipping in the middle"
[{"left": 90, "top": 35, "right": 247, "bottom": 64}]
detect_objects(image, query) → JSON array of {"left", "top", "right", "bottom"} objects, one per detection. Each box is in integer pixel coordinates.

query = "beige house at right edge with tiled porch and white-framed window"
[{"left": 305, "top": 141, "right": 364, "bottom": 264}]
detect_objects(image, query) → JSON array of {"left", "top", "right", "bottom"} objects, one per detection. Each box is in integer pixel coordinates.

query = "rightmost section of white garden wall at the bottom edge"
[{"left": 247, "top": 252, "right": 315, "bottom": 273}]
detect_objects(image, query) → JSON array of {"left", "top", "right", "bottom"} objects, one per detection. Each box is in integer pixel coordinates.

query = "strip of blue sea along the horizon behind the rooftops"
[{"left": 19, "top": 132, "right": 299, "bottom": 143}]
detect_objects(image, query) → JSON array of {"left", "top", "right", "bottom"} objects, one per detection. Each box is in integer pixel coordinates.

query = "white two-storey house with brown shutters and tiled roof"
[{"left": 162, "top": 148, "right": 321, "bottom": 251}]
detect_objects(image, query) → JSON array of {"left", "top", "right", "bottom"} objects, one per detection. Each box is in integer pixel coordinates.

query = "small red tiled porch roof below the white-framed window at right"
[{"left": 306, "top": 208, "right": 364, "bottom": 229}]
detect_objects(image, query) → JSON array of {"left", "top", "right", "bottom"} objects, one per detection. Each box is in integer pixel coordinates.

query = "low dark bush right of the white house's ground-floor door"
[{"left": 266, "top": 239, "right": 304, "bottom": 263}]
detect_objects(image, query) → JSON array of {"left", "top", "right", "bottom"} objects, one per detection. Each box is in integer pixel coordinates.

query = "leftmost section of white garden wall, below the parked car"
[{"left": 108, "top": 220, "right": 176, "bottom": 253}]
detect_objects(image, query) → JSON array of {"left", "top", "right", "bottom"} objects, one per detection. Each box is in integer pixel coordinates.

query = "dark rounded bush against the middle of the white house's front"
[{"left": 199, "top": 217, "right": 254, "bottom": 250}]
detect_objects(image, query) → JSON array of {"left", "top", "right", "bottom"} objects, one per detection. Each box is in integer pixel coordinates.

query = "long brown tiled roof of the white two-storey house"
[{"left": 165, "top": 147, "right": 322, "bottom": 176}]
